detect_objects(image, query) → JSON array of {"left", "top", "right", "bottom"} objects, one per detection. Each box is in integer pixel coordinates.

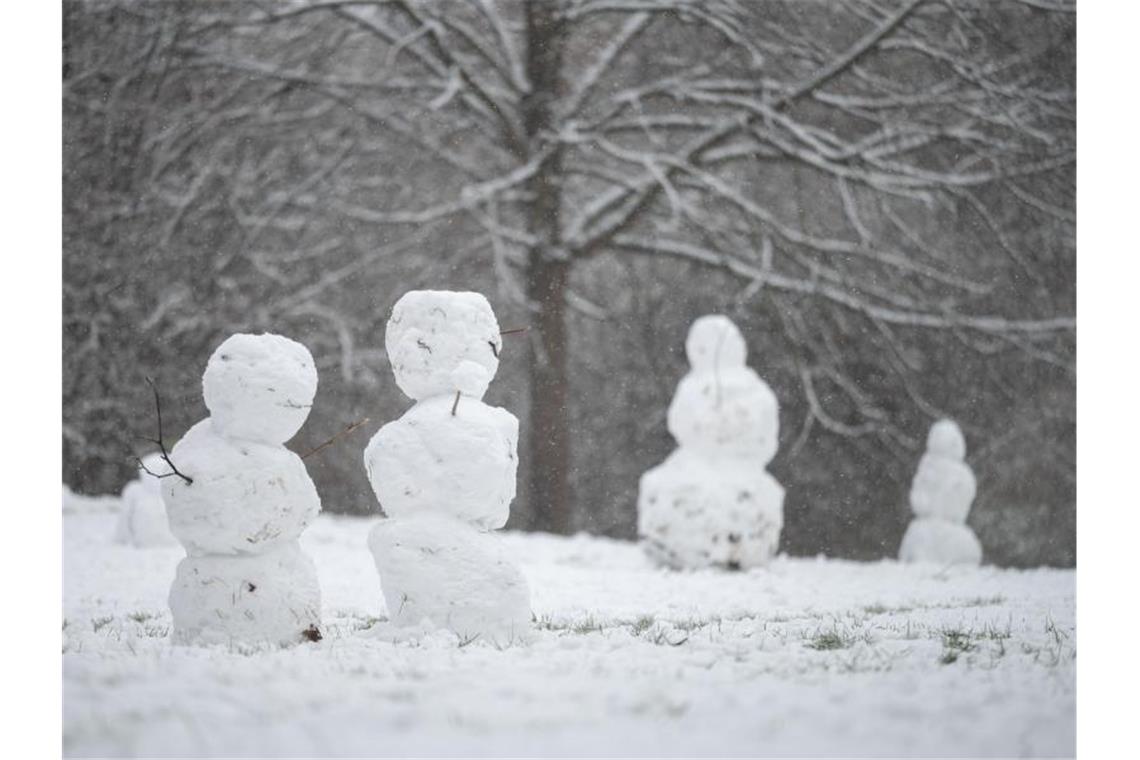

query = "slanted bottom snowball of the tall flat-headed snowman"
[{"left": 368, "top": 514, "right": 531, "bottom": 646}]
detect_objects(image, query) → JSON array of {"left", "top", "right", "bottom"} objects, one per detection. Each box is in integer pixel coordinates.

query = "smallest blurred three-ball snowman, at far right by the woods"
[{"left": 898, "top": 419, "right": 982, "bottom": 565}]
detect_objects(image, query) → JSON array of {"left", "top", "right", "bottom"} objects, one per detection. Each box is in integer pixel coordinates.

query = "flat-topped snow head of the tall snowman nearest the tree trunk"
[{"left": 384, "top": 291, "right": 503, "bottom": 401}]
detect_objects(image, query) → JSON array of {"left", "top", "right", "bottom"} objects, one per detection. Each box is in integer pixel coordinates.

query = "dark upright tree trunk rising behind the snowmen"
[{"left": 523, "top": 1, "right": 571, "bottom": 533}]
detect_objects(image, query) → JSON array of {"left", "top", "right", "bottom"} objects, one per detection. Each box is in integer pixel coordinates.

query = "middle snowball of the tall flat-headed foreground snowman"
[{"left": 364, "top": 397, "right": 519, "bottom": 530}]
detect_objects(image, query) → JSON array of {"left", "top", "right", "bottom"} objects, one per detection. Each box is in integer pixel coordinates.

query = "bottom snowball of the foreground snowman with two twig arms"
[{"left": 170, "top": 541, "right": 320, "bottom": 644}]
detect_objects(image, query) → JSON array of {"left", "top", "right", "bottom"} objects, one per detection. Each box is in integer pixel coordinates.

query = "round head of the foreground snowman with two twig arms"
[{"left": 202, "top": 333, "right": 317, "bottom": 443}]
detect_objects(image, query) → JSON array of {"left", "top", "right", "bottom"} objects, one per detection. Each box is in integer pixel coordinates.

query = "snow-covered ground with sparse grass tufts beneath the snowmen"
[{"left": 63, "top": 502, "right": 1076, "bottom": 757}]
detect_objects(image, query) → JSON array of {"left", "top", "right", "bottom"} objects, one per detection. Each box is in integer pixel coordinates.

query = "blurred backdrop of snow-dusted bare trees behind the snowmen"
[{"left": 63, "top": 0, "right": 1075, "bottom": 564}]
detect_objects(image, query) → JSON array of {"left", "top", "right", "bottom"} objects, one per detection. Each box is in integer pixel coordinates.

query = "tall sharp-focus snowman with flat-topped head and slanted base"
[{"left": 364, "top": 291, "right": 531, "bottom": 645}]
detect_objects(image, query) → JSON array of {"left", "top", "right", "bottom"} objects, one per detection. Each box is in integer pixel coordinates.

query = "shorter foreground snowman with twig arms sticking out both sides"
[{"left": 163, "top": 334, "right": 320, "bottom": 644}]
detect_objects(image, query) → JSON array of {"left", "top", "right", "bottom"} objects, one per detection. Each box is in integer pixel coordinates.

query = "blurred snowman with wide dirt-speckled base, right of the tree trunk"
[{"left": 637, "top": 314, "right": 784, "bottom": 570}]
